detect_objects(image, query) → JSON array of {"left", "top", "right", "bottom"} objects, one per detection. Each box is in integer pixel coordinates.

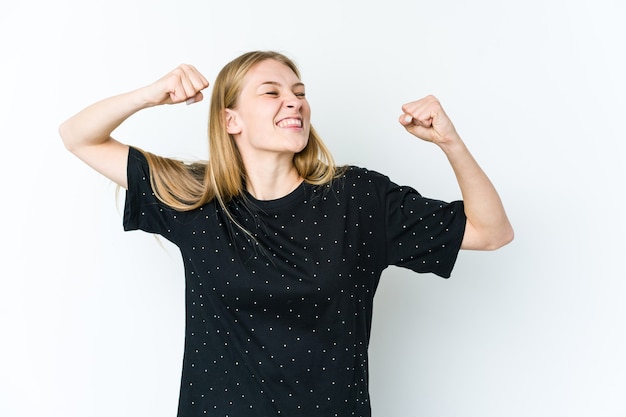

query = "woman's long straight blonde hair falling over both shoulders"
[{"left": 140, "top": 51, "right": 342, "bottom": 214}]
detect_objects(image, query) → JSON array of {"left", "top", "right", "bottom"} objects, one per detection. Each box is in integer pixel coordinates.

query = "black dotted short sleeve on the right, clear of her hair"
[{"left": 386, "top": 182, "right": 466, "bottom": 278}]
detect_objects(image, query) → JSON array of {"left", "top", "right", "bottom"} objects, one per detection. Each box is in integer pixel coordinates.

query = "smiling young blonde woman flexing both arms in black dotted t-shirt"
[{"left": 60, "top": 51, "right": 513, "bottom": 417}]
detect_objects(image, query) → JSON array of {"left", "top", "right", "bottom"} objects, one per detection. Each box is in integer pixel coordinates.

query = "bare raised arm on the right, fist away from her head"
[{"left": 400, "top": 96, "right": 513, "bottom": 250}]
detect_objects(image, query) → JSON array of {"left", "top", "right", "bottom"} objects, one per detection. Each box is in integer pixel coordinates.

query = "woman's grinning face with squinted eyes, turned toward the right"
[{"left": 226, "top": 59, "right": 311, "bottom": 157}]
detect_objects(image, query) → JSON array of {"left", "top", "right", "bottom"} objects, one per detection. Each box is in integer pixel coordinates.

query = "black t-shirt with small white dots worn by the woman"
[{"left": 124, "top": 148, "right": 465, "bottom": 417}]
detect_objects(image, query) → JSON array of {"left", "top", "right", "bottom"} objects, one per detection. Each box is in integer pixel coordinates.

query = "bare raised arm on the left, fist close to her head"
[{"left": 59, "top": 64, "right": 209, "bottom": 188}]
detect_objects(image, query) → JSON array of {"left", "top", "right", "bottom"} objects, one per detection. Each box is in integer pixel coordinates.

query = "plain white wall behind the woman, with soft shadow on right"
[{"left": 0, "top": 0, "right": 626, "bottom": 417}]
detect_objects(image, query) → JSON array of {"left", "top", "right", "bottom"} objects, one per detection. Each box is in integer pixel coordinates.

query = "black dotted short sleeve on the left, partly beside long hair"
[{"left": 123, "top": 147, "right": 171, "bottom": 235}]
